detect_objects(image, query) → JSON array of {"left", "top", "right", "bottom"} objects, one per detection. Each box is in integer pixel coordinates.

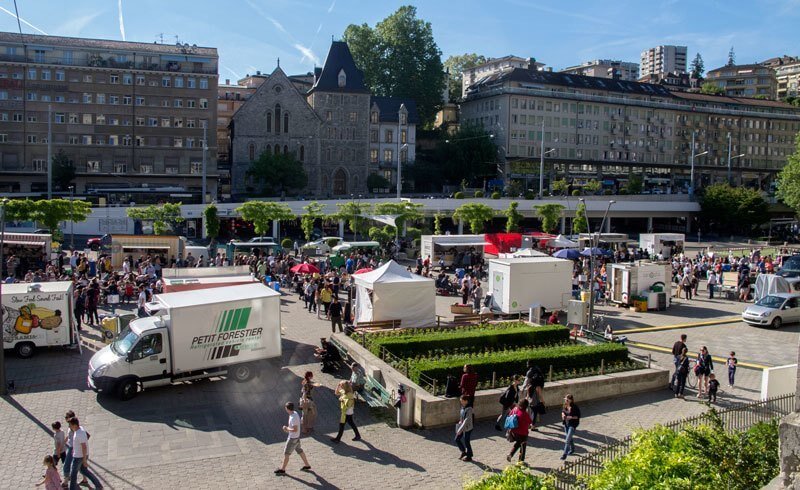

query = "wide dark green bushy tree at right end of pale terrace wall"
[{"left": 700, "top": 183, "right": 769, "bottom": 234}]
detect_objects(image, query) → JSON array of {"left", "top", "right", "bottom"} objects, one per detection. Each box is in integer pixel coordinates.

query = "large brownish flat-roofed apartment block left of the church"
[{"left": 0, "top": 32, "right": 218, "bottom": 203}]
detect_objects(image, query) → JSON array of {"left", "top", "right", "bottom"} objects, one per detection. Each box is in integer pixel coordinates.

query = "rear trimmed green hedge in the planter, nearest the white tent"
[{"left": 369, "top": 322, "right": 569, "bottom": 359}]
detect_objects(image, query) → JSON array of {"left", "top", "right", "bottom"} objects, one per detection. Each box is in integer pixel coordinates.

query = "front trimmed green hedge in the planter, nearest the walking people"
[{"left": 409, "top": 343, "right": 628, "bottom": 383}]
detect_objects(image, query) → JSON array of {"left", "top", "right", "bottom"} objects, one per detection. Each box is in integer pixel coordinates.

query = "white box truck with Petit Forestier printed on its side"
[{"left": 88, "top": 284, "right": 281, "bottom": 400}]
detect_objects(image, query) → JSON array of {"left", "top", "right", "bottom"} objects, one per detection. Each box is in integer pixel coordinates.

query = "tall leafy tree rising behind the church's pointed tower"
[{"left": 343, "top": 5, "right": 445, "bottom": 125}]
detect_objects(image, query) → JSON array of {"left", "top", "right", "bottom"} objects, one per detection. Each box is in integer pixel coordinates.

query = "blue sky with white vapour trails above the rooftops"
[{"left": 0, "top": 0, "right": 800, "bottom": 80}]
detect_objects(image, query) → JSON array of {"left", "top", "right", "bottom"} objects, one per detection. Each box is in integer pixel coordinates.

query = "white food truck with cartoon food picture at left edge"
[{"left": 2, "top": 281, "right": 78, "bottom": 358}]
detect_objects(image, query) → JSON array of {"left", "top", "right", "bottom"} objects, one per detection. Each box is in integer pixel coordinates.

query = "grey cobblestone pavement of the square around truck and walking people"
[{"left": 0, "top": 288, "right": 768, "bottom": 489}]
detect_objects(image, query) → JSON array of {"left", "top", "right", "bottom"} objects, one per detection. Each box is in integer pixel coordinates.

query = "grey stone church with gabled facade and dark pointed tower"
[{"left": 231, "top": 41, "right": 380, "bottom": 198}]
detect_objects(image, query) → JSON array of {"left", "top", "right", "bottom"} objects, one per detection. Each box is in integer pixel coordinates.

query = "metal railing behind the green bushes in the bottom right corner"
[{"left": 550, "top": 393, "right": 795, "bottom": 490}]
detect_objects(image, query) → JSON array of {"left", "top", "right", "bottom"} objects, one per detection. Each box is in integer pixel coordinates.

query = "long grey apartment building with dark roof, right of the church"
[{"left": 461, "top": 69, "right": 800, "bottom": 192}]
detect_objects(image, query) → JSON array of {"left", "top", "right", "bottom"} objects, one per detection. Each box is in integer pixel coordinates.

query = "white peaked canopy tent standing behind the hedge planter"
[{"left": 353, "top": 260, "right": 436, "bottom": 327}]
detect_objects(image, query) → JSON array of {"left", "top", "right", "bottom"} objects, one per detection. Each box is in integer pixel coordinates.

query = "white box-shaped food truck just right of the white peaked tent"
[{"left": 488, "top": 256, "right": 573, "bottom": 314}]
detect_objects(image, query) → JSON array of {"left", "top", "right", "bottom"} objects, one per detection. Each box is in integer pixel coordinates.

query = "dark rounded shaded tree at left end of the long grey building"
[{"left": 433, "top": 124, "right": 497, "bottom": 190}]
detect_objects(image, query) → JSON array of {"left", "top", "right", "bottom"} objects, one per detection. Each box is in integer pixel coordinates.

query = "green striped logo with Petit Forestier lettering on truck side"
[{"left": 191, "top": 306, "right": 264, "bottom": 360}]
